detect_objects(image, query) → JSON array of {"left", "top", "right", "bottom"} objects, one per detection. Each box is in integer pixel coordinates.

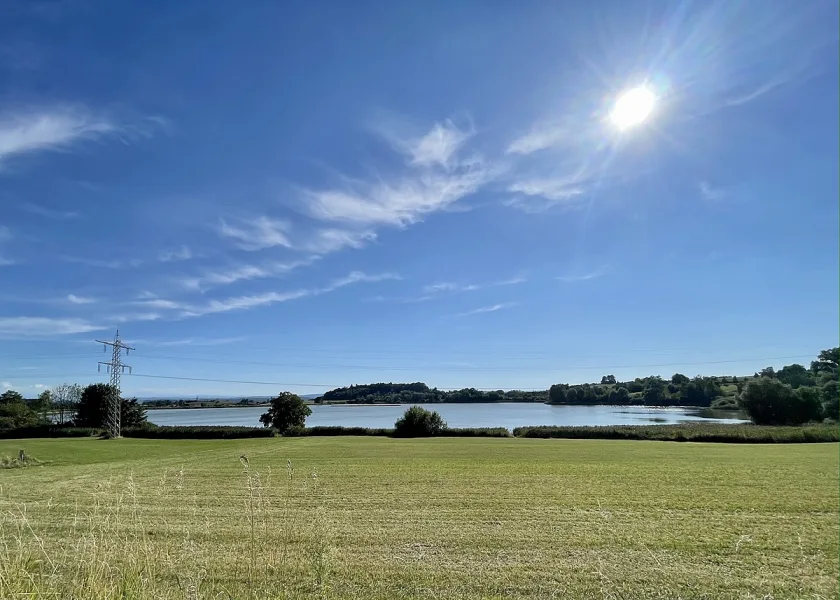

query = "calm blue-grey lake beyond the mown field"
[{"left": 148, "top": 402, "right": 744, "bottom": 429}]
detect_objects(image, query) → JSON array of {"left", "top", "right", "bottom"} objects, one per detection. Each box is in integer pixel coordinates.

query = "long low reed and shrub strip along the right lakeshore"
[{"left": 513, "top": 423, "right": 840, "bottom": 444}]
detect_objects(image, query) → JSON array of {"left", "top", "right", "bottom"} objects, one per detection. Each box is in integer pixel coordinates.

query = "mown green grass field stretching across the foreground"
[{"left": 0, "top": 437, "right": 840, "bottom": 600}]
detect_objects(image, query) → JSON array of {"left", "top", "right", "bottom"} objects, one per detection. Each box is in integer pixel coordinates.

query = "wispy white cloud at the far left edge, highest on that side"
[{"left": 0, "top": 106, "right": 118, "bottom": 164}]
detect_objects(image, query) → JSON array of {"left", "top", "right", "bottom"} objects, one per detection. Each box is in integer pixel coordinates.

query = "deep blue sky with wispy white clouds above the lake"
[{"left": 0, "top": 0, "right": 840, "bottom": 396}]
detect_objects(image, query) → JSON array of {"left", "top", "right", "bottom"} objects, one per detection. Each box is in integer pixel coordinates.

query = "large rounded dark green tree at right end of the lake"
[{"left": 738, "top": 377, "right": 822, "bottom": 425}]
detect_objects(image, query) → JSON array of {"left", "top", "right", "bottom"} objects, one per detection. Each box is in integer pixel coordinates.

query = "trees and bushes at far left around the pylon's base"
[{"left": 0, "top": 383, "right": 146, "bottom": 430}]
